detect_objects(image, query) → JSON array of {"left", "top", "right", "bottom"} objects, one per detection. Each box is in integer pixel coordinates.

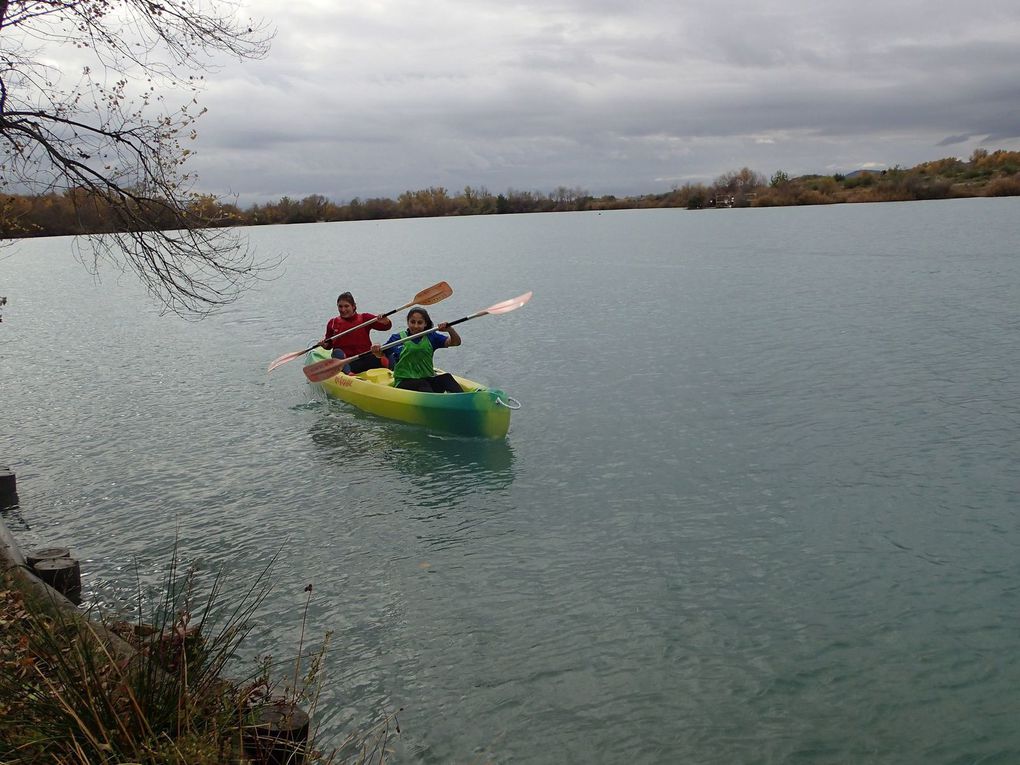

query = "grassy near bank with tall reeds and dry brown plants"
[{"left": 0, "top": 518, "right": 400, "bottom": 765}]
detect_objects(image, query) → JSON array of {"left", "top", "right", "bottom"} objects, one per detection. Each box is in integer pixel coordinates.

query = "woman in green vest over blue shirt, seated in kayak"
[{"left": 372, "top": 308, "right": 464, "bottom": 393}]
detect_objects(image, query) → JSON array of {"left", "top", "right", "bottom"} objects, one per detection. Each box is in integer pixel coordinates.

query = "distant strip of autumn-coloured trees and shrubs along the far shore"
[{"left": 0, "top": 144, "right": 1020, "bottom": 239}]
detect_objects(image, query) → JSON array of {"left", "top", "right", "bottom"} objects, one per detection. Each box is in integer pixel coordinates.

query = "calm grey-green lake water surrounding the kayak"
[{"left": 0, "top": 199, "right": 1020, "bottom": 764}]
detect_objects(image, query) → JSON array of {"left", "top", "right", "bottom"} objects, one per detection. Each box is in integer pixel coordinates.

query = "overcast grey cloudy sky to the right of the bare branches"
[{"left": 183, "top": 0, "right": 1020, "bottom": 205}]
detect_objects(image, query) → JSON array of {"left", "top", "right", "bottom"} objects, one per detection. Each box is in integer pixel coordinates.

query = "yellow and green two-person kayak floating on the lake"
[{"left": 308, "top": 347, "right": 520, "bottom": 439}]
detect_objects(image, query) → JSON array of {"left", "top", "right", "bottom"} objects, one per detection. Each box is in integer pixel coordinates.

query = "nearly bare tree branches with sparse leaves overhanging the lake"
[{"left": 0, "top": 0, "right": 271, "bottom": 314}]
